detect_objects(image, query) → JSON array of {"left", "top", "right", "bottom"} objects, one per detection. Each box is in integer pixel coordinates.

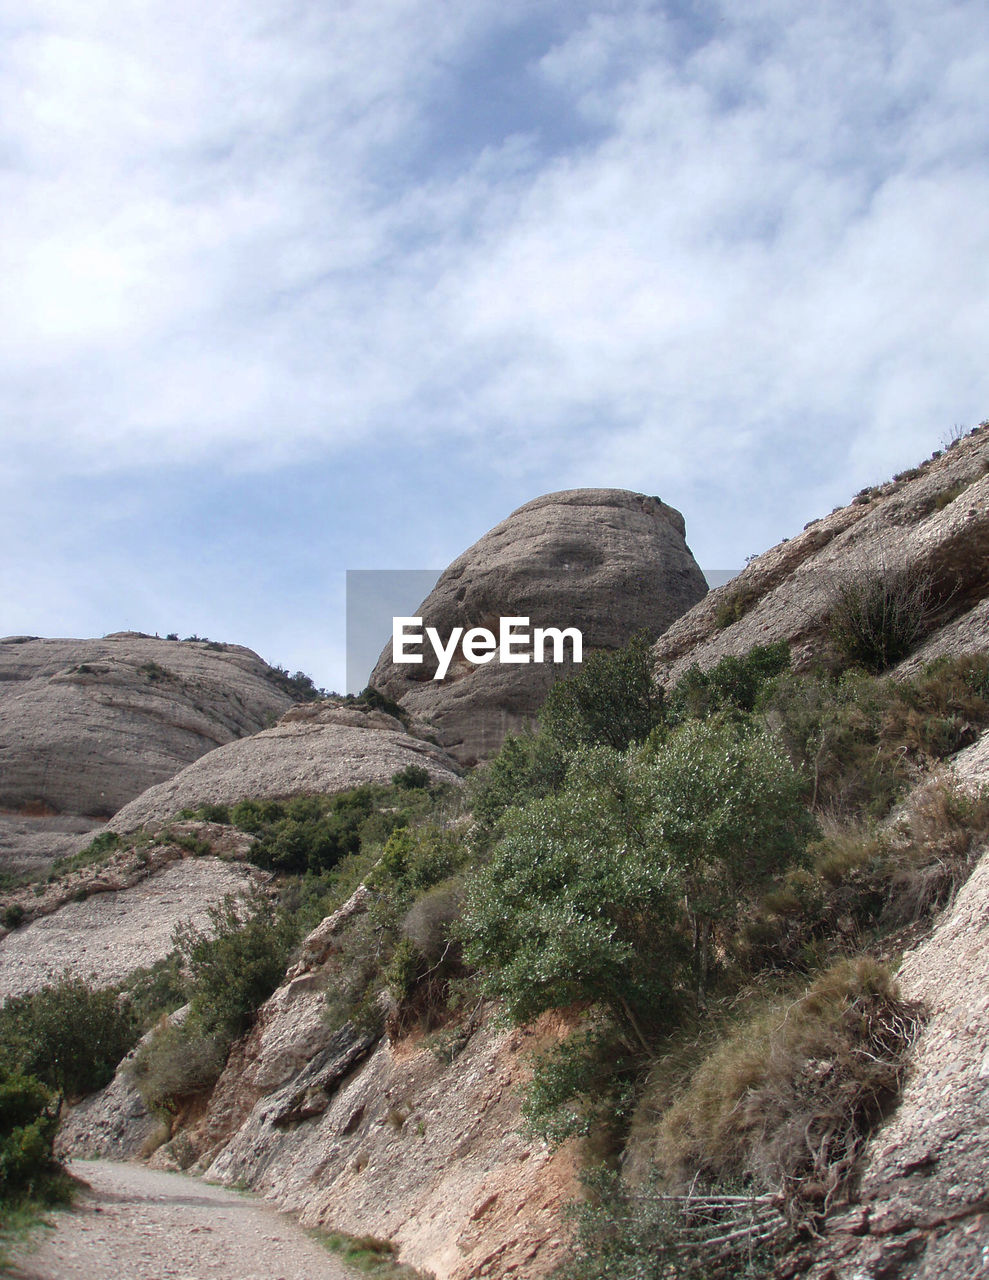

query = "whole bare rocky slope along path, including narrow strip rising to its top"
[{"left": 69, "top": 890, "right": 577, "bottom": 1280}]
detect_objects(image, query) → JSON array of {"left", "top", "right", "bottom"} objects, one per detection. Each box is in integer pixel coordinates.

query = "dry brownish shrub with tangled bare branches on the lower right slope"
[{"left": 658, "top": 957, "right": 921, "bottom": 1219}]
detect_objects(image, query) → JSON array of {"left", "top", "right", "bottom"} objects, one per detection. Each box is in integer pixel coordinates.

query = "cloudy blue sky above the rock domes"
[{"left": 0, "top": 0, "right": 989, "bottom": 689}]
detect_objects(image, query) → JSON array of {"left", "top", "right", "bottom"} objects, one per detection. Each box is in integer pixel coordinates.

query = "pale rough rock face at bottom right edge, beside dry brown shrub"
[{"left": 810, "top": 735, "right": 989, "bottom": 1280}]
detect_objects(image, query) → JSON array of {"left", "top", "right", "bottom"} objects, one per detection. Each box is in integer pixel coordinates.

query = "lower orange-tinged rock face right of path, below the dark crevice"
[{"left": 205, "top": 1008, "right": 577, "bottom": 1280}]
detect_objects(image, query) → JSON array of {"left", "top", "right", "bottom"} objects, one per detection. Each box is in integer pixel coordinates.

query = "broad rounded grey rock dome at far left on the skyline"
[{"left": 0, "top": 632, "right": 293, "bottom": 861}]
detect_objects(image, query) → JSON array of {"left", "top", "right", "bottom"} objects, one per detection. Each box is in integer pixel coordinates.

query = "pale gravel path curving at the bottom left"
[{"left": 0, "top": 1160, "right": 353, "bottom": 1280}]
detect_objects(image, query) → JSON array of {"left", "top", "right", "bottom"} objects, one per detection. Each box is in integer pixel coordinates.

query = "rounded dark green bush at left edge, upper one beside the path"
[{"left": 0, "top": 978, "right": 138, "bottom": 1098}]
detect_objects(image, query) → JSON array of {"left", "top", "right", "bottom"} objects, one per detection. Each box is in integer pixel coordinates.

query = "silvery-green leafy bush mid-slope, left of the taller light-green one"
[{"left": 458, "top": 748, "right": 682, "bottom": 1044}]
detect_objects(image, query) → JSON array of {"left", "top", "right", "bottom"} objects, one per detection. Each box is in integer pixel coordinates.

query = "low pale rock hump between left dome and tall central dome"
[{"left": 109, "top": 703, "right": 459, "bottom": 832}]
